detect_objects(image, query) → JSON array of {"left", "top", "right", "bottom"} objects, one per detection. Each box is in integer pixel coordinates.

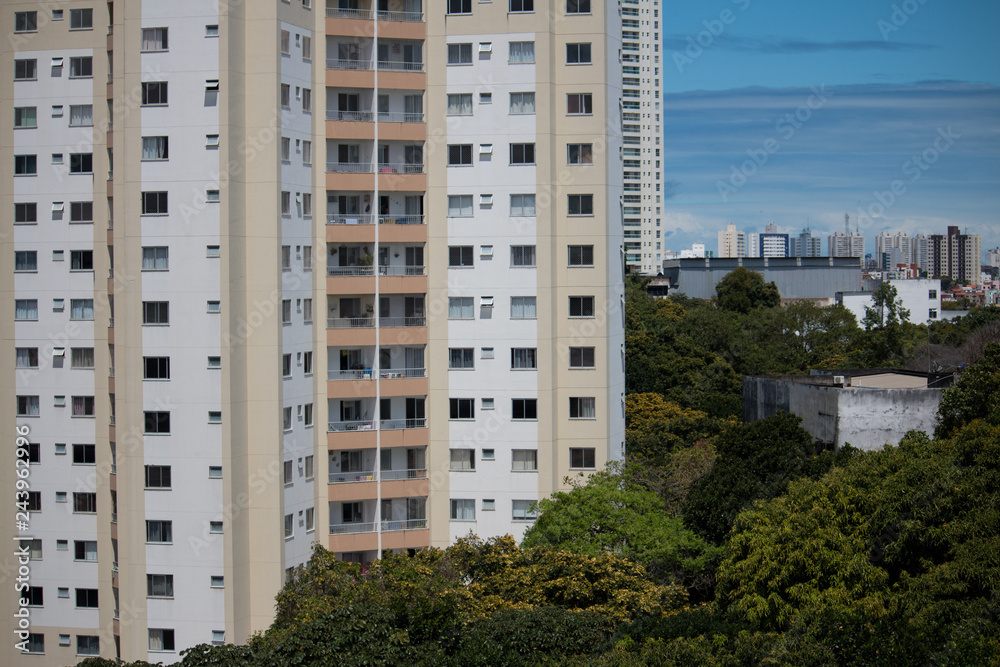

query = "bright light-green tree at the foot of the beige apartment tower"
[{"left": 522, "top": 464, "right": 719, "bottom": 587}]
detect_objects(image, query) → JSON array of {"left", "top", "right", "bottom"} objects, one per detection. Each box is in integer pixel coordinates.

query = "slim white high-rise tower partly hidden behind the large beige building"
[{"left": 616, "top": 0, "right": 664, "bottom": 275}]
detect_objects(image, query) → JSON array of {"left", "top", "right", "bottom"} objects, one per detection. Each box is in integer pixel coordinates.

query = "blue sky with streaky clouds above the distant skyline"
[{"left": 661, "top": 0, "right": 1000, "bottom": 252}]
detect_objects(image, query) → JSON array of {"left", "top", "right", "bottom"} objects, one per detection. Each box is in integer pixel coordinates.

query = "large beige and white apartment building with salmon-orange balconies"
[{"left": 0, "top": 0, "right": 624, "bottom": 665}]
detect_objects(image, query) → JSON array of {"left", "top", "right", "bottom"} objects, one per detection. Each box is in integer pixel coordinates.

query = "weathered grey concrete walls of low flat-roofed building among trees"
[{"left": 743, "top": 377, "right": 941, "bottom": 451}]
